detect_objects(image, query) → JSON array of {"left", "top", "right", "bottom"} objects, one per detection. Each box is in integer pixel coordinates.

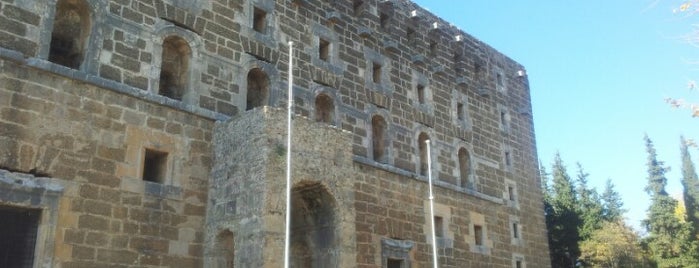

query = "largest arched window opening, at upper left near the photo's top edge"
[{"left": 49, "top": 0, "right": 91, "bottom": 69}]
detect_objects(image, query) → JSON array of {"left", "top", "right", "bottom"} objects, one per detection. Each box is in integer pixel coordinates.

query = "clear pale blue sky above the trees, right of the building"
[{"left": 414, "top": 0, "right": 699, "bottom": 228}]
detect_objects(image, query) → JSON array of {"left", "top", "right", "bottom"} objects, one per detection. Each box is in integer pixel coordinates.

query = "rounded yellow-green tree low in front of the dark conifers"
[{"left": 580, "top": 221, "right": 650, "bottom": 268}]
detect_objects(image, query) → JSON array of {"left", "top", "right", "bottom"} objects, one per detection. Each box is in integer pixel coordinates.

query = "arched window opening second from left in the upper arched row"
[{"left": 158, "top": 36, "right": 192, "bottom": 100}]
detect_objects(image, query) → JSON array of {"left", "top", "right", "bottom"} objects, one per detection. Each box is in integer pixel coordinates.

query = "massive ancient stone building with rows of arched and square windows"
[{"left": 0, "top": 0, "right": 550, "bottom": 268}]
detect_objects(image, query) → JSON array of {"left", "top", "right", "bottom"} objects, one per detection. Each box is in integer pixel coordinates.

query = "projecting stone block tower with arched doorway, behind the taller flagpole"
[{"left": 205, "top": 107, "right": 357, "bottom": 267}]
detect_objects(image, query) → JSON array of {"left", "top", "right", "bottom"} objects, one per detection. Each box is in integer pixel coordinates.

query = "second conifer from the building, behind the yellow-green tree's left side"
[{"left": 576, "top": 163, "right": 603, "bottom": 240}]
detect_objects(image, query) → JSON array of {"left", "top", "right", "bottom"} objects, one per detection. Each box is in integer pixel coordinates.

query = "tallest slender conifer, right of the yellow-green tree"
[{"left": 643, "top": 136, "right": 697, "bottom": 267}]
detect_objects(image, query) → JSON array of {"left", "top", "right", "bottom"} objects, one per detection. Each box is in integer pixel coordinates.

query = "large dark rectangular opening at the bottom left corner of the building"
[{"left": 0, "top": 206, "right": 41, "bottom": 268}]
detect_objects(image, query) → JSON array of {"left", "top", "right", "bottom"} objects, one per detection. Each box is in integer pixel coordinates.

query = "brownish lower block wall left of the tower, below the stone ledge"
[{"left": 0, "top": 59, "right": 214, "bottom": 267}]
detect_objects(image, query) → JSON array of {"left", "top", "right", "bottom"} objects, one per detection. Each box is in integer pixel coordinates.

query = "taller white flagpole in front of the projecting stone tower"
[{"left": 284, "top": 41, "right": 294, "bottom": 268}]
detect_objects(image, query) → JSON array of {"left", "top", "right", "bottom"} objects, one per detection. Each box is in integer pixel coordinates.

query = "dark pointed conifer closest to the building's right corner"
[{"left": 546, "top": 154, "right": 580, "bottom": 267}]
